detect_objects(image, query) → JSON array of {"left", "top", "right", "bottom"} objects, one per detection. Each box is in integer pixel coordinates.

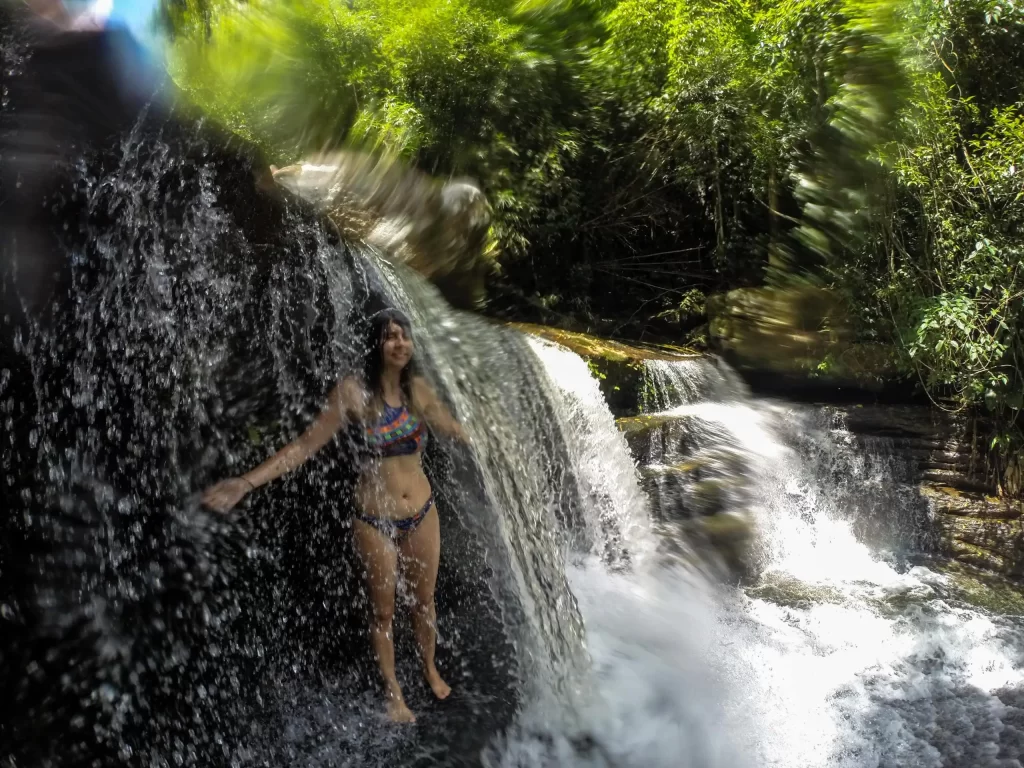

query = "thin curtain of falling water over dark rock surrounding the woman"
[{"left": 5, "top": 163, "right": 602, "bottom": 765}]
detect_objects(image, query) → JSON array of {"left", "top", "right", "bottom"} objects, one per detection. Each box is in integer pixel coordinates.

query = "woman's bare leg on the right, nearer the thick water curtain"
[{"left": 398, "top": 507, "right": 452, "bottom": 698}]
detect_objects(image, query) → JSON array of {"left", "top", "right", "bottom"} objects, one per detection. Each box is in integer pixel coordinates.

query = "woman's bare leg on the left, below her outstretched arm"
[{"left": 352, "top": 520, "right": 416, "bottom": 723}]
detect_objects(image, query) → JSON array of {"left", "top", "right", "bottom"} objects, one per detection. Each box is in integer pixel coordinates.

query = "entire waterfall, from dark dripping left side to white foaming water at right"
[{"left": 0, "top": 9, "right": 1024, "bottom": 768}]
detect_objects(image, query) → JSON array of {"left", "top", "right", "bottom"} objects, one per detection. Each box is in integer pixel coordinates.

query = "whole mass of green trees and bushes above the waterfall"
[{"left": 153, "top": 0, "right": 1024, "bottom": 489}]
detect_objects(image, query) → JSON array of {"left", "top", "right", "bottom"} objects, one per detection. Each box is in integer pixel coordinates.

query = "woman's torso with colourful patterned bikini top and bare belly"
[{"left": 355, "top": 402, "right": 430, "bottom": 520}]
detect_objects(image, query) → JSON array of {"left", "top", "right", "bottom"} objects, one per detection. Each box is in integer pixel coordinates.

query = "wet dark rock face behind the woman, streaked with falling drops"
[{"left": 0, "top": 13, "right": 515, "bottom": 766}]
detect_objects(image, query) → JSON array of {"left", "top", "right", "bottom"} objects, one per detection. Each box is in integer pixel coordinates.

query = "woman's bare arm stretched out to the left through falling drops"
[{"left": 203, "top": 377, "right": 366, "bottom": 512}]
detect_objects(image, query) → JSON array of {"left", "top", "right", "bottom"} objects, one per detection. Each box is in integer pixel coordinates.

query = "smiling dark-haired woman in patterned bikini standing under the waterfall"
[{"left": 203, "top": 309, "right": 468, "bottom": 723}]
